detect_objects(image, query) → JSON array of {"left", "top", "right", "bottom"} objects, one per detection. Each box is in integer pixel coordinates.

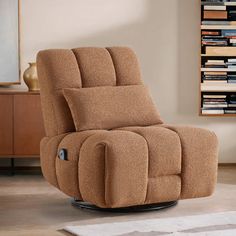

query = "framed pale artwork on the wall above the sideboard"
[{"left": 0, "top": 0, "right": 21, "bottom": 85}]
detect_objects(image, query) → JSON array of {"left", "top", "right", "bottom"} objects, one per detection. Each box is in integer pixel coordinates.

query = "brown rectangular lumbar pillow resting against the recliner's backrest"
[{"left": 63, "top": 85, "right": 162, "bottom": 131}]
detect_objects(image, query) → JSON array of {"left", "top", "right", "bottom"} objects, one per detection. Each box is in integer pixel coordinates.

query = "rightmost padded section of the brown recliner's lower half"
[{"left": 160, "top": 126, "right": 218, "bottom": 199}]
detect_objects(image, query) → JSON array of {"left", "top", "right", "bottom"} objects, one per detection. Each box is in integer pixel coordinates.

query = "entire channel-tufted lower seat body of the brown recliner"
[{"left": 41, "top": 124, "right": 218, "bottom": 207}]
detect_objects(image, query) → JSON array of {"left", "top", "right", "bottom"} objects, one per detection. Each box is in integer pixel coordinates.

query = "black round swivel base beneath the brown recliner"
[{"left": 71, "top": 199, "right": 177, "bottom": 213}]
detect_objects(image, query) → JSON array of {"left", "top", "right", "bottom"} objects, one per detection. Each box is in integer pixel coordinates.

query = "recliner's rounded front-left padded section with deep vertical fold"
[{"left": 79, "top": 130, "right": 148, "bottom": 208}]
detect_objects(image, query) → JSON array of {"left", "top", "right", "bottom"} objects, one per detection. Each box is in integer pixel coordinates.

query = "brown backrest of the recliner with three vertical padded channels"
[{"left": 37, "top": 47, "right": 142, "bottom": 136}]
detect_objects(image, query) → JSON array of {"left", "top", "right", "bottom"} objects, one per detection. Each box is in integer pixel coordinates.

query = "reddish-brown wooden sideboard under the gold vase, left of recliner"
[{"left": 0, "top": 90, "right": 45, "bottom": 171}]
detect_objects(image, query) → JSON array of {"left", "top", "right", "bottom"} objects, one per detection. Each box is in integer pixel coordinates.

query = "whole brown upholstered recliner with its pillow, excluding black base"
[{"left": 37, "top": 47, "right": 218, "bottom": 209}]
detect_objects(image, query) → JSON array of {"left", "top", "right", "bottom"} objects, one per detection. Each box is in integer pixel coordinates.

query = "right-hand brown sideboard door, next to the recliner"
[{"left": 14, "top": 94, "right": 45, "bottom": 156}]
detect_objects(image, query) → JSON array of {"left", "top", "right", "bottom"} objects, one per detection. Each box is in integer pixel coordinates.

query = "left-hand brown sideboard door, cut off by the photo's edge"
[{"left": 0, "top": 94, "right": 13, "bottom": 155}]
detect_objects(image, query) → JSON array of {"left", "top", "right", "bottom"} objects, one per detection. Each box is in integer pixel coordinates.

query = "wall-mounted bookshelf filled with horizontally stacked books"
[{"left": 199, "top": 0, "right": 236, "bottom": 117}]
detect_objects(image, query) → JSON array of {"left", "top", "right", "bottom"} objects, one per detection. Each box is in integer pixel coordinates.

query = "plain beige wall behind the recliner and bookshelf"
[{"left": 9, "top": 0, "right": 236, "bottom": 162}]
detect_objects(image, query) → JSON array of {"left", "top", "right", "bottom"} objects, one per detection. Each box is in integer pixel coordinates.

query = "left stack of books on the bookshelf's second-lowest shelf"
[{"left": 202, "top": 71, "right": 228, "bottom": 84}]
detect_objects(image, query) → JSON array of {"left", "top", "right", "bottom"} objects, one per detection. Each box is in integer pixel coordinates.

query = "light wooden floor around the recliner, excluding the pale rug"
[{"left": 0, "top": 167, "right": 236, "bottom": 236}]
